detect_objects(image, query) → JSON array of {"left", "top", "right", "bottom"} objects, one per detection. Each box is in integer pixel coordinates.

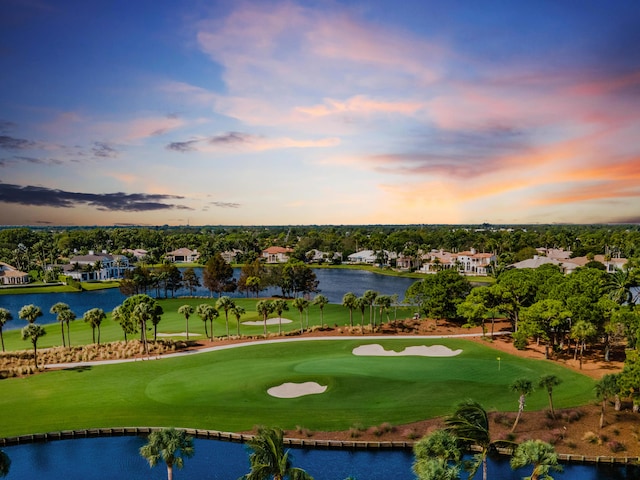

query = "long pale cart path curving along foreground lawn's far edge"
[{"left": 45, "top": 332, "right": 511, "bottom": 369}]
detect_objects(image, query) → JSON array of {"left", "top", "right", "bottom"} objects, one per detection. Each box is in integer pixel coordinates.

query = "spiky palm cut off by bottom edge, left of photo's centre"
[{"left": 241, "top": 427, "right": 313, "bottom": 480}]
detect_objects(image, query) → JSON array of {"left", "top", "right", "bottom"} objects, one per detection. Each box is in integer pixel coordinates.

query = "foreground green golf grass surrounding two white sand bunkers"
[{"left": 0, "top": 339, "right": 594, "bottom": 436}]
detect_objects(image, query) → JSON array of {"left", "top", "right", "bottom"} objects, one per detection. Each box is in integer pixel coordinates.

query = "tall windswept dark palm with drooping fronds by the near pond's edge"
[{"left": 445, "top": 400, "right": 494, "bottom": 480}]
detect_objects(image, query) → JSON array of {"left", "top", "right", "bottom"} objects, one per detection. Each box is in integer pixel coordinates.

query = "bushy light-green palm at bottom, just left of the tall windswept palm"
[{"left": 413, "top": 430, "right": 462, "bottom": 480}]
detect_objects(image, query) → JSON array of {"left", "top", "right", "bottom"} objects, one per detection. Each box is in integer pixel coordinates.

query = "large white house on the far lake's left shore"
[{"left": 63, "top": 250, "right": 133, "bottom": 282}]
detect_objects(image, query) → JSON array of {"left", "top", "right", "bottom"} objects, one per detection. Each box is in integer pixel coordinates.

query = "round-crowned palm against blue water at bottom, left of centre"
[{"left": 140, "top": 428, "right": 195, "bottom": 480}]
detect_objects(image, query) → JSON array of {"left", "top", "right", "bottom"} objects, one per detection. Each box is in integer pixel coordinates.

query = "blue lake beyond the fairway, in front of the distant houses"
[{"left": 0, "top": 268, "right": 416, "bottom": 330}]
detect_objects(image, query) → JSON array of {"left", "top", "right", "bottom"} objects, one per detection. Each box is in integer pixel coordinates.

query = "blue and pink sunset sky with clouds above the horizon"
[{"left": 0, "top": 0, "right": 640, "bottom": 226}]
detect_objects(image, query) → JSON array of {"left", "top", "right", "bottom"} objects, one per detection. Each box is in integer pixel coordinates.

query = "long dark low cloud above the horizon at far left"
[{"left": 0, "top": 183, "right": 191, "bottom": 212}]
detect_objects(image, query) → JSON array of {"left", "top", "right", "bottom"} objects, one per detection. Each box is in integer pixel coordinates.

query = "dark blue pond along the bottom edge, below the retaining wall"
[{"left": 4, "top": 437, "right": 640, "bottom": 480}]
